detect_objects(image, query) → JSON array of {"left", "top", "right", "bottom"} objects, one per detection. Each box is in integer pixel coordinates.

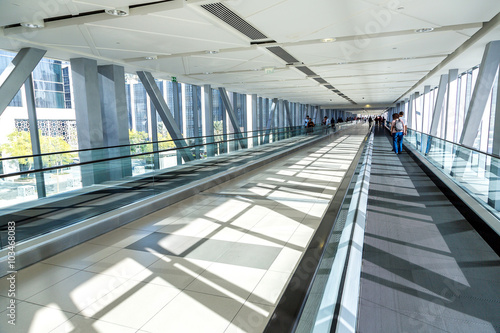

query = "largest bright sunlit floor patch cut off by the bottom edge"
[{"left": 141, "top": 291, "right": 242, "bottom": 333}]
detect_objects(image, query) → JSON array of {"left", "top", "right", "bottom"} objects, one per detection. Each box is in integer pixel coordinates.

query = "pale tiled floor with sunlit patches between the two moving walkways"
[{"left": 0, "top": 126, "right": 366, "bottom": 333}]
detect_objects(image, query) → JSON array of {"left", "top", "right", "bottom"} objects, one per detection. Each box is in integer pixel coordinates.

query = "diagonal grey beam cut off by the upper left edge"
[{"left": 0, "top": 47, "right": 47, "bottom": 116}]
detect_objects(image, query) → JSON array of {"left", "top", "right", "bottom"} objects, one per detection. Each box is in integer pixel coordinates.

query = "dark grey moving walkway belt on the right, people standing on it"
[{"left": 358, "top": 127, "right": 500, "bottom": 333}]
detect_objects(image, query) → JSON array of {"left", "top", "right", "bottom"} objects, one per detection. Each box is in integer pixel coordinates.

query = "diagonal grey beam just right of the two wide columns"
[{"left": 137, "top": 71, "right": 193, "bottom": 162}]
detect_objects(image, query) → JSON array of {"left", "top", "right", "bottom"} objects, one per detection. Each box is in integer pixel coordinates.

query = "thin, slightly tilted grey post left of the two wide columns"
[{"left": 24, "top": 74, "right": 47, "bottom": 198}]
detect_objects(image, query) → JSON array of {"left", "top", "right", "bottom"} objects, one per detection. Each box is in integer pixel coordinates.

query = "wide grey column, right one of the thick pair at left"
[{"left": 97, "top": 65, "right": 131, "bottom": 179}]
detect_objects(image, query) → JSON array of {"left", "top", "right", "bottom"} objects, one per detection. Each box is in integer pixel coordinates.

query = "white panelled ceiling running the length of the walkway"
[{"left": 0, "top": 0, "right": 500, "bottom": 107}]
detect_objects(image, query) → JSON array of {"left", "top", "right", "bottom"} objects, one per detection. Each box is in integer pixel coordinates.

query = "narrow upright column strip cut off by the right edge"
[{"left": 488, "top": 73, "right": 500, "bottom": 210}]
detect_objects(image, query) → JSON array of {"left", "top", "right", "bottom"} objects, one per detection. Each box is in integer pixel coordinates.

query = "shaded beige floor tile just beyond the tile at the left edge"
[{"left": 43, "top": 242, "right": 119, "bottom": 269}]
